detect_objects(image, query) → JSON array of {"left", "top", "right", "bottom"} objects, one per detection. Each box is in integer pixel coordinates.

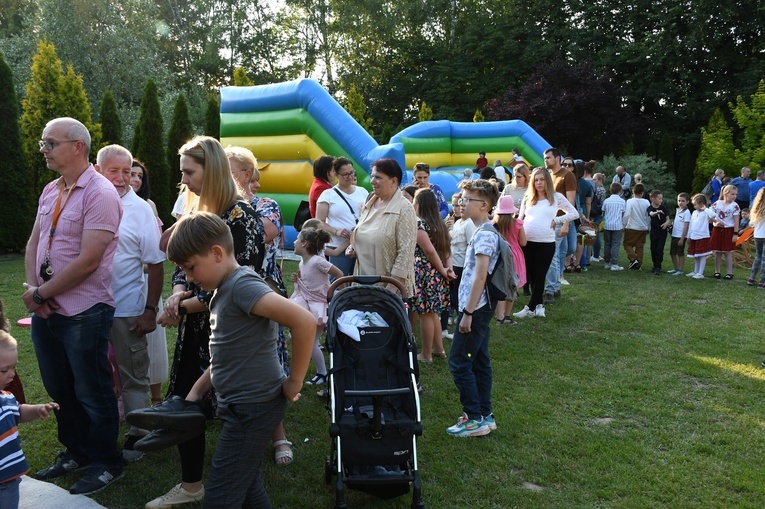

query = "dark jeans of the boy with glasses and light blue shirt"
[{"left": 449, "top": 304, "right": 494, "bottom": 420}]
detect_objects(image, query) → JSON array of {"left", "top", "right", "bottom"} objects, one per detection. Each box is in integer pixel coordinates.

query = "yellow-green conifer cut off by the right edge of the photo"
[{"left": 728, "top": 80, "right": 765, "bottom": 173}]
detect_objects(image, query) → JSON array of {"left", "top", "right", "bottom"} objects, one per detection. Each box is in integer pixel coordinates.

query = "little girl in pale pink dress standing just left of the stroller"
[{"left": 290, "top": 228, "right": 343, "bottom": 385}]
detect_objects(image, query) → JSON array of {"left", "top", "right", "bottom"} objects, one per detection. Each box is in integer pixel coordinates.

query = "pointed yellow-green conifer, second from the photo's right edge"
[{"left": 693, "top": 108, "right": 741, "bottom": 192}]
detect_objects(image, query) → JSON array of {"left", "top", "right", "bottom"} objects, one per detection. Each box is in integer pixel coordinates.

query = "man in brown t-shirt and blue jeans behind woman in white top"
[{"left": 543, "top": 148, "right": 577, "bottom": 304}]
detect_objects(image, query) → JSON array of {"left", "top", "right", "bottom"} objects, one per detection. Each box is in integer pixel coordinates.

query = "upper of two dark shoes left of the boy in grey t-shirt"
[{"left": 125, "top": 396, "right": 207, "bottom": 433}]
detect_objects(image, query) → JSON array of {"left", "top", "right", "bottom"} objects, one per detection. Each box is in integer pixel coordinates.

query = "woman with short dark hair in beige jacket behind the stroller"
[{"left": 348, "top": 158, "right": 417, "bottom": 295}]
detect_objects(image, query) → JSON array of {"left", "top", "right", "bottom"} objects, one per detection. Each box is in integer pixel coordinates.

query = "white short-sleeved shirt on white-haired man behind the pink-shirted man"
[{"left": 112, "top": 189, "right": 165, "bottom": 317}]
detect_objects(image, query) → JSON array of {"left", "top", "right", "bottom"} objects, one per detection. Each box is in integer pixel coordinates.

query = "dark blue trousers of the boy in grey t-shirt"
[{"left": 205, "top": 394, "right": 287, "bottom": 509}]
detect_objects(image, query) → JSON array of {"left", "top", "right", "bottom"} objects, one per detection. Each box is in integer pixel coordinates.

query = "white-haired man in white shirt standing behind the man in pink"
[{"left": 96, "top": 145, "right": 165, "bottom": 461}]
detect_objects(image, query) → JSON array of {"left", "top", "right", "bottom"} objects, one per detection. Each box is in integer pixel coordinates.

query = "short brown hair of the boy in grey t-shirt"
[{"left": 167, "top": 212, "right": 234, "bottom": 265}]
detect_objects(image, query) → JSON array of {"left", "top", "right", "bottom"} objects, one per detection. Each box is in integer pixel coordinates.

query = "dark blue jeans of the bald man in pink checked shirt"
[{"left": 32, "top": 303, "right": 122, "bottom": 466}]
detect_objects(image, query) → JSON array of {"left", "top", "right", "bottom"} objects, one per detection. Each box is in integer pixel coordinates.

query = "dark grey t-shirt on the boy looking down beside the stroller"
[{"left": 210, "top": 267, "right": 285, "bottom": 404}]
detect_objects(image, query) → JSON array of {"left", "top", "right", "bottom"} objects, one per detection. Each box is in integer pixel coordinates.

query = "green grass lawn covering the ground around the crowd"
[{"left": 0, "top": 248, "right": 765, "bottom": 509}]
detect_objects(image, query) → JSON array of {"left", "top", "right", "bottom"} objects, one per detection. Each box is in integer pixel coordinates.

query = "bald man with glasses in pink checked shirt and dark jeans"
[{"left": 22, "top": 118, "right": 124, "bottom": 495}]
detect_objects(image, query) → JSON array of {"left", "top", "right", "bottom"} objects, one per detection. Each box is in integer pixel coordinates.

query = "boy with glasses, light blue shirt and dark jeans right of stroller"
[{"left": 446, "top": 180, "right": 499, "bottom": 437}]
